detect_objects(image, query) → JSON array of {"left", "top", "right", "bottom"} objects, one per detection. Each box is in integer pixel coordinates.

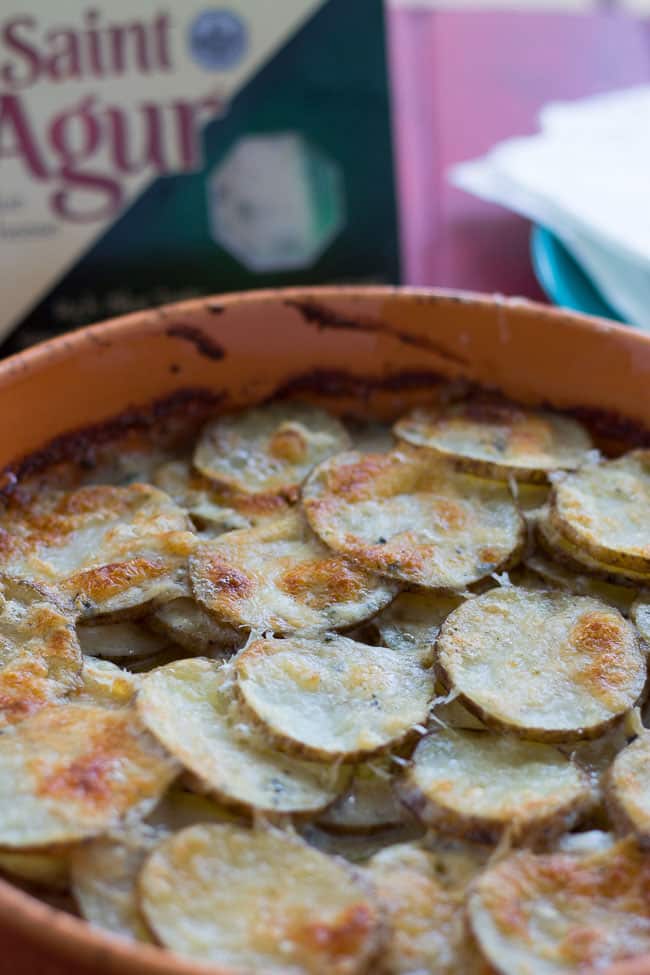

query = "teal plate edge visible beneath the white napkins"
[{"left": 530, "top": 226, "right": 624, "bottom": 322}]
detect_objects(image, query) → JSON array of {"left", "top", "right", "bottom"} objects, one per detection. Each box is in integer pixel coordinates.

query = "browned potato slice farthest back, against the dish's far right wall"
[{"left": 394, "top": 401, "right": 593, "bottom": 482}]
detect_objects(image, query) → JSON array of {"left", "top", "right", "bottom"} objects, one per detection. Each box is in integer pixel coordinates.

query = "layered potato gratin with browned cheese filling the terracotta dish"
[{"left": 0, "top": 392, "right": 650, "bottom": 975}]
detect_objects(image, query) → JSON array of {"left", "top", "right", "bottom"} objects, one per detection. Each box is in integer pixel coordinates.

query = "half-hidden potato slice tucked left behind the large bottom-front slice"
[{"left": 70, "top": 823, "right": 162, "bottom": 944}]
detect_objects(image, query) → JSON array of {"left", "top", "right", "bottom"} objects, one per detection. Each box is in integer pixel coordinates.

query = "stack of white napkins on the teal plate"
[{"left": 450, "top": 85, "right": 650, "bottom": 329}]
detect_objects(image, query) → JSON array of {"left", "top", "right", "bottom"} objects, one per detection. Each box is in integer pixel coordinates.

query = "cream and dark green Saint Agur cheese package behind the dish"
[{"left": 0, "top": 0, "right": 399, "bottom": 348}]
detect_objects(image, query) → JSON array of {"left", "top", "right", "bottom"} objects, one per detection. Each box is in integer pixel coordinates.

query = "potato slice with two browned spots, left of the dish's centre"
[{"left": 190, "top": 511, "right": 398, "bottom": 633}]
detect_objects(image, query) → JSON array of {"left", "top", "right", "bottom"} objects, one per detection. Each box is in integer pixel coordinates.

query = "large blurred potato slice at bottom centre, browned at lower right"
[{"left": 139, "top": 825, "right": 384, "bottom": 975}]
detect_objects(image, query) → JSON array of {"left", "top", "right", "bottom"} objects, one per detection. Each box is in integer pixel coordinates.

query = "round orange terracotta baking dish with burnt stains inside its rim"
[{"left": 0, "top": 288, "right": 650, "bottom": 975}]
